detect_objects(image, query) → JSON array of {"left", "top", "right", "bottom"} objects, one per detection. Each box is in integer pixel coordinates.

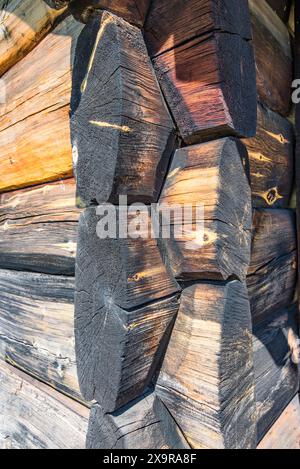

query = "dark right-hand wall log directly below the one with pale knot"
[{"left": 247, "top": 209, "right": 297, "bottom": 323}]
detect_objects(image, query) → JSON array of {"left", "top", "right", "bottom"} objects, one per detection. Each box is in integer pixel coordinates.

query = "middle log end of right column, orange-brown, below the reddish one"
[{"left": 160, "top": 138, "right": 252, "bottom": 280}]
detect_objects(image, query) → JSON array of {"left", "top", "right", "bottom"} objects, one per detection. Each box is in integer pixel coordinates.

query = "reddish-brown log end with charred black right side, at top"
[{"left": 145, "top": 0, "right": 256, "bottom": 144}]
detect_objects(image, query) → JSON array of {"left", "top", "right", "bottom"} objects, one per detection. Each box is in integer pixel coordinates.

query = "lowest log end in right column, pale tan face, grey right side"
[{"left": 157, "top": 281, "right": 256, "bottom": 449}]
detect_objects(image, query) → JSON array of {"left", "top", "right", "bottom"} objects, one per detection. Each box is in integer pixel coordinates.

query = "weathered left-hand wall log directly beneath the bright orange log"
[{"left": 0, "top": 179, "right": 80, "bottom": 275}]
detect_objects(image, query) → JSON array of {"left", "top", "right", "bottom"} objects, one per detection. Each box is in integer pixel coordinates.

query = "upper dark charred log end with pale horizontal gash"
[{"left": 71, "top": 12, "right": 175, "bottom": 204}]
